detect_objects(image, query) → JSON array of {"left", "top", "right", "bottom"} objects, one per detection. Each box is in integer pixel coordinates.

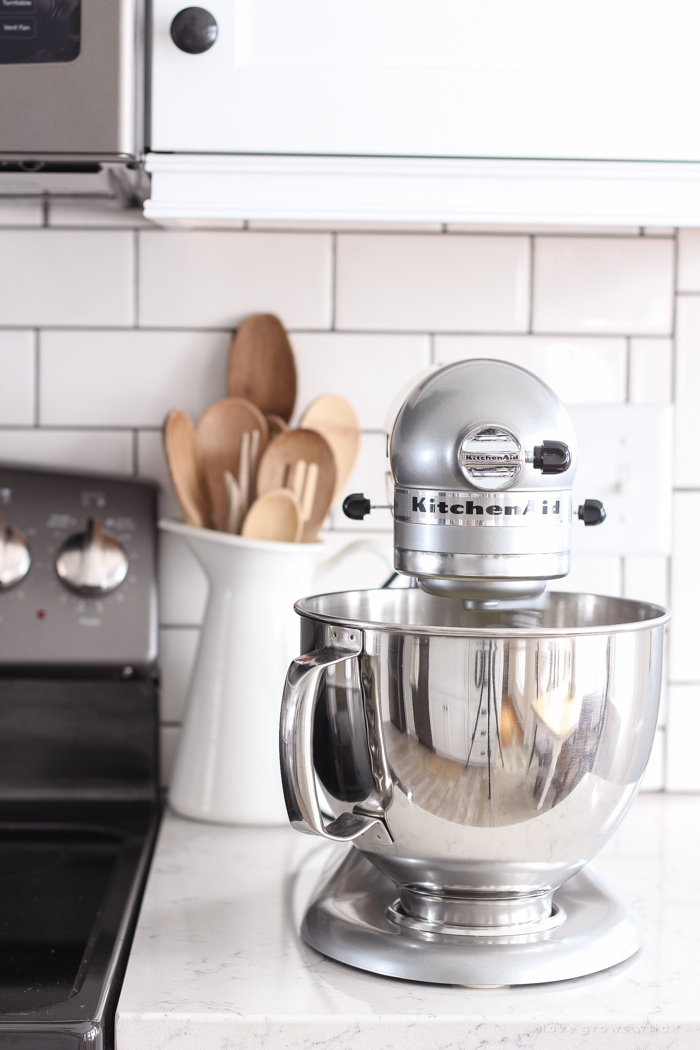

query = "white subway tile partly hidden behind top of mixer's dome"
[{"left": 434, "top": 335, "right": 627, "bottom": 404}]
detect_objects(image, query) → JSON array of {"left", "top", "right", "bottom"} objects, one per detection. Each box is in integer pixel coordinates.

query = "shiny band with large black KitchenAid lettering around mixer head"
[{"left": 394, "top": 488, "right": 571, "bottom": 526}]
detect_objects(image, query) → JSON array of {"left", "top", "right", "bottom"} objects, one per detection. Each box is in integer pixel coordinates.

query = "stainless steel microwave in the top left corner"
[{"left": 0, "top": 0, "right": 146, "bottom": 161}]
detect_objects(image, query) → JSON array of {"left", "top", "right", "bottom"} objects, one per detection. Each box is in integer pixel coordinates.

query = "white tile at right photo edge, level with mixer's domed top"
[{"left": 674, "top": 295, "right": 700, "bottom": 488}]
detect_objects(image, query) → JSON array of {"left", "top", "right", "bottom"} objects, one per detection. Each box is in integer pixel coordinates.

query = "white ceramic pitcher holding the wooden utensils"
[{"left": 160, "top": 521, "right": 390, "bottom": 824}]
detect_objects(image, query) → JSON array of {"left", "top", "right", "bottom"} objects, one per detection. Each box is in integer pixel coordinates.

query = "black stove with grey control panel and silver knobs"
[{"left": 0, "top": 467, "right": 160, "bottom": 1050}]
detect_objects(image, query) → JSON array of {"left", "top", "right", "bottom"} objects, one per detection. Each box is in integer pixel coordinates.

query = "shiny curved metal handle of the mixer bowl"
[{"left": 279, "top": 627, "right": 393, "bottom": 843}]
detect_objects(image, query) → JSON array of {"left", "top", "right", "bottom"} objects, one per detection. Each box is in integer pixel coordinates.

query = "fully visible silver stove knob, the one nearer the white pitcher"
[{"left": 56, "top": 518, "right": 129, "bottom": 595}]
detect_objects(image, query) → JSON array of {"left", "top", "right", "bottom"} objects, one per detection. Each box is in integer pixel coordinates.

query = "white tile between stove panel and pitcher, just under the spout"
[{"left": 158, "top": 532, "right": 209, "bottom": 627}]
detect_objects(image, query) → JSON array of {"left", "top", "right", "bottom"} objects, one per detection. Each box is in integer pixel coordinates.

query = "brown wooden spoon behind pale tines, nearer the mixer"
[{"left": 257, "top": 431, "right": 336, "bottom": 543}]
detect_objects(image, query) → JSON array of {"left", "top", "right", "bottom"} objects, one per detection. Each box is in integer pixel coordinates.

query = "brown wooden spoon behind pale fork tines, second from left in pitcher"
[{"left": 197, "top": 397, "right": 268, "bottom": 531}]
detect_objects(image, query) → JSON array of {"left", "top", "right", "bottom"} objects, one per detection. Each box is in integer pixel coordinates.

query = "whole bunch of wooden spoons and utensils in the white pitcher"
[{"left": 164, "top": 314, "right": 360, "bottom": 543}]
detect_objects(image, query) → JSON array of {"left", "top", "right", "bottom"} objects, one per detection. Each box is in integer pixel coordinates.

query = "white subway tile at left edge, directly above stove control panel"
[{"left": 0, "top": 427, "right": 133, "bottom": 474}]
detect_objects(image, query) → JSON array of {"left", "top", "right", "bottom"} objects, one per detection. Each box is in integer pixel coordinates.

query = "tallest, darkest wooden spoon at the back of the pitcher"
[{"left": 228, "top": 314, "right": 297, "bottom": 422}]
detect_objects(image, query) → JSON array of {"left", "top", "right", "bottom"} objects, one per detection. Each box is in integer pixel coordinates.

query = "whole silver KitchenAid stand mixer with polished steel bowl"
[{"left": 280, "top": 360, "right": 670, "bottom": 986}]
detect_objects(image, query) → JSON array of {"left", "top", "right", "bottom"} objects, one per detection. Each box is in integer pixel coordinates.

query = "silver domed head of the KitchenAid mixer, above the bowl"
[{"left": 346, "top": 359, "right": 604, "bottom": 606}]
